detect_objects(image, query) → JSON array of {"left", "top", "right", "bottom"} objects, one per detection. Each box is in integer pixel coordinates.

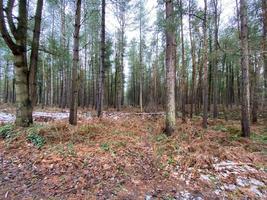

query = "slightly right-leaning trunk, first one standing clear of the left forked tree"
[{"left": 69, "top": 0, "right": 81, "bottom": 125}]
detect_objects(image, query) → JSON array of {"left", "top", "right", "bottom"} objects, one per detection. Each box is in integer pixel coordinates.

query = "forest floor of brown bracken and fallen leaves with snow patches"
[{"left": 0, "top": 105, "right": 267, "bottom": 200}]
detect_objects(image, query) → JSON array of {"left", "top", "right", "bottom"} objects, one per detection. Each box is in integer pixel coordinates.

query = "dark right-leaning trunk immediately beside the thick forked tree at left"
[{"left": 29, "top": 0, "right": 43, "bottom": 107}]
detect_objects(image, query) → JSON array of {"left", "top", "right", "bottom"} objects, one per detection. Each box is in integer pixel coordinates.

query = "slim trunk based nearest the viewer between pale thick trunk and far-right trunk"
[{"left": 202, "top": 0, "right": 208, "bottom": 128}]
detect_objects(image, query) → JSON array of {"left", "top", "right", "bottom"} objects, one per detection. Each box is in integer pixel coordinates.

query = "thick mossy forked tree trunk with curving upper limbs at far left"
[{"left": 0, "top": 0, "right": 33, "bottom": 126}]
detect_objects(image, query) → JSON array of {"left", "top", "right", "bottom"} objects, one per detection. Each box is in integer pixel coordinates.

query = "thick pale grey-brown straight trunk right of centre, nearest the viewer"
[{"left": 165, "top": 0, "right": 176, "bottom": 135}]
